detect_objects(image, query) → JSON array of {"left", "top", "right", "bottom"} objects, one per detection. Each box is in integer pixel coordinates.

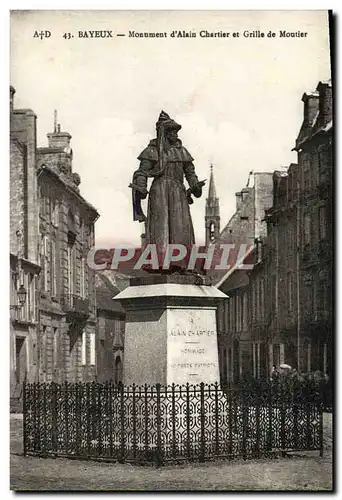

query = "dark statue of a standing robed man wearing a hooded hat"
[{"left": 130, "top": 111, "right": 205, "bottom": 270}]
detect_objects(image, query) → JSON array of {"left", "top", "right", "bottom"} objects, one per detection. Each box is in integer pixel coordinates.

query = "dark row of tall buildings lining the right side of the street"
[{"left": 216, "top": 82, "right": 333, "bottom": 382}]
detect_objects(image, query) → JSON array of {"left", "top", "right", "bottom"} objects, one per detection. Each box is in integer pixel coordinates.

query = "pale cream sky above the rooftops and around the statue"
[{"left": 10, "top": 11, "right": 331, "bottom": 245}]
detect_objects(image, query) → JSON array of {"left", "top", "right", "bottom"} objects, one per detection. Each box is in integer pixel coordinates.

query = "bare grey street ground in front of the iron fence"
[{"left": 10, "top": 414, "right": 332, "bottom": 491}]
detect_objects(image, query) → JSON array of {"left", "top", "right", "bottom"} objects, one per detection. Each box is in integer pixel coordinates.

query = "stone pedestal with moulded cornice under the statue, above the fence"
[{"left": 115, "top": 275, "right": 227, "bottom": 385}]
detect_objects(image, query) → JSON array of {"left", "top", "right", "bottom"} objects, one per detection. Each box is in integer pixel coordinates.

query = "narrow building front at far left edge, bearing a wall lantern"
[{"left": 9, "top": 87, "right": 40, "bottom": 398}]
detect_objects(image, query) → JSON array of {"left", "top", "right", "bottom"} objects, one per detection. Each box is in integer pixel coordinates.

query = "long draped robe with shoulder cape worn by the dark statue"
[{"left": 133, "top": 139, "right": 200, "bottom": 262}]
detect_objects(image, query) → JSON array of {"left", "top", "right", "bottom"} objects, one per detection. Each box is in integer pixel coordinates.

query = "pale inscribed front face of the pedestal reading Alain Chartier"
[{"left": 167, "top": 309, "right": 219, "bottom": 384}]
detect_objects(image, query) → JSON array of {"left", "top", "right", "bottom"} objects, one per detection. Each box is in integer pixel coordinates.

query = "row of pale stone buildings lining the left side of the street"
[{"left": 10, "top": 87, "right": 98, "bottom": 397}]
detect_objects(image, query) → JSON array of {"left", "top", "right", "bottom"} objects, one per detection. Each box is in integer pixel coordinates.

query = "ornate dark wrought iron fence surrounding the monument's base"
[{"left": 23, "top": 382, "right": 323, "bottom": 464}]
